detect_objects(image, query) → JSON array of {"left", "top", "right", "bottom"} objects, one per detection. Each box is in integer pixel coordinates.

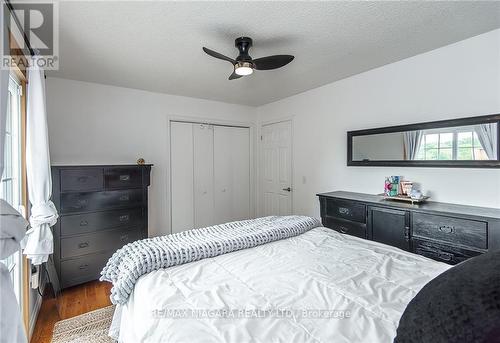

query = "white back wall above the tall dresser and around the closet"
[{"left": 47, "top": 78, "right": 256, "bottom": 236}]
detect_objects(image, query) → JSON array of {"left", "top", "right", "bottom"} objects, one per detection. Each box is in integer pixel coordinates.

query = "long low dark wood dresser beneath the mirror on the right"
[{"left": 318, "top": 192, "right": 500, "bottom": 264}]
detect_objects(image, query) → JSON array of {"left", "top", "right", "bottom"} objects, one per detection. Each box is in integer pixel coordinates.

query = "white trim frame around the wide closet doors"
[{"left": 165, "top": 115, "right": 258, "bottom": 234}]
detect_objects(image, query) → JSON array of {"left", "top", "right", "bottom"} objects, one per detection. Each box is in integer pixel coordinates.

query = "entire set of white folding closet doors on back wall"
[{"left": 170, "top": 122, "right": 250, "bottom": 233}]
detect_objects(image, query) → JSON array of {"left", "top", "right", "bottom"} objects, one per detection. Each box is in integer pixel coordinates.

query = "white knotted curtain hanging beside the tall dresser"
[{"left": 21, "top": 56, "right": 58, "bottom": 265}]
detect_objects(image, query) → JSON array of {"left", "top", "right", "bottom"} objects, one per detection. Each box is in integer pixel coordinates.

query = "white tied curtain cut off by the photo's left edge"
[{"left": 0, "top": 1, "right": 28, "bottom": 343}]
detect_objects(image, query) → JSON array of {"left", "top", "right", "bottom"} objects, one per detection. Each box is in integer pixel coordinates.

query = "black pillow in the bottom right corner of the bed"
[{"left": 394, "top": 251, "right": 500, "bottom": 343}]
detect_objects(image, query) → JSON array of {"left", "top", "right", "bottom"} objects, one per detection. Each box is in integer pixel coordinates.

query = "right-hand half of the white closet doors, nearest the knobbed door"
[{"left": 214, "top": 126, "right": 250, "bottom": 224}]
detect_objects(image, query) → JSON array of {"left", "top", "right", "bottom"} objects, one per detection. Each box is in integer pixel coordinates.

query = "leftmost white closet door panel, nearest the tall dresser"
[{"left": 170, "top": 122, "right": 194, "bottom": 233}]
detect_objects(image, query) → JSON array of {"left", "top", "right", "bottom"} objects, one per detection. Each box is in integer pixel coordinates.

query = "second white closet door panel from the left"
[{"left": 192, "top": 124, "right": 215, "bottom": 228}]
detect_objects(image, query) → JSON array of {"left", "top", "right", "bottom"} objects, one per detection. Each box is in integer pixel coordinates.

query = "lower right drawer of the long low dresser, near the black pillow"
[{"left": 413, "top": 239, "right": 481, "bottom": 264}]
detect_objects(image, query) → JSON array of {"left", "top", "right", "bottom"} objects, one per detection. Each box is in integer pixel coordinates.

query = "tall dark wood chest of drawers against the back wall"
[{"left": 52, "top": 165, "right": 151, "bottom": 288}]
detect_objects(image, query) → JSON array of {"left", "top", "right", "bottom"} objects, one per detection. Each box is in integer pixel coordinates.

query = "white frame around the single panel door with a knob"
[{"left": 257, "top": 115, "right": 295, "bottom": 217}]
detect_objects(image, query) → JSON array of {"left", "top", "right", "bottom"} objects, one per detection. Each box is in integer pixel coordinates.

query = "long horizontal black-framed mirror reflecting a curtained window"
[{"left": 347, "top": 114, "right": 500, "bottom": 168}]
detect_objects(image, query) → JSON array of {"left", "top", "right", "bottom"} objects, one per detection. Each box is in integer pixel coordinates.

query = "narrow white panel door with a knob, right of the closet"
[{"left": 261, "top": 121, "right": 292, "bottom": 216}]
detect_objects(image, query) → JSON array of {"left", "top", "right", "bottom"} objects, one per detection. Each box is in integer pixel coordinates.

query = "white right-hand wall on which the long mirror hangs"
[{"left": 259, "top": 30, "right": 500, "bottom": 215}]
